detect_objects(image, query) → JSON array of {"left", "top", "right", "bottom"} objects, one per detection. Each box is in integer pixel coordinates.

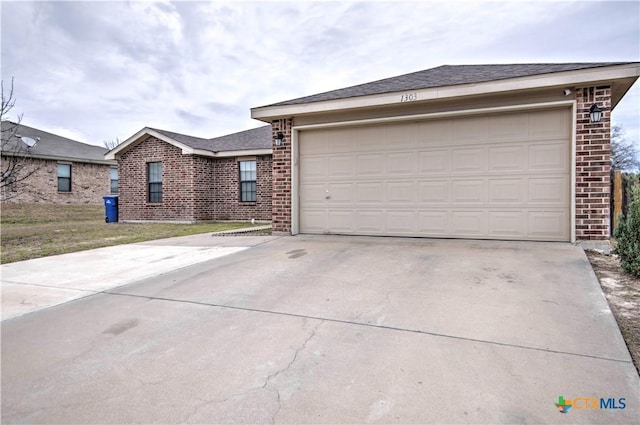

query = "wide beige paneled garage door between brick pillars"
[{"left": 298, "top": 108, "right": 571, "bottom": 241}]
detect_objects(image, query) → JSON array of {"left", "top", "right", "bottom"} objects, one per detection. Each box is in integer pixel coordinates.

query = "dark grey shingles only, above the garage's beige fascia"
[{"left": 265, "top": 62, "right": 634, "bottom": 107}]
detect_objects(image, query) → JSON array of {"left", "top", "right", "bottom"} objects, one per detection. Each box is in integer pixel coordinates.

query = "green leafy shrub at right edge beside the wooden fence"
[{"left": 614, "top": 185, "right": 640, "bottom": 277}]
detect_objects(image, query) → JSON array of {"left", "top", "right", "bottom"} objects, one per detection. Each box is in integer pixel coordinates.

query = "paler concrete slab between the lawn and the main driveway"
[{"left": 0, "top": 232, "right": 280, "bottom": 320}]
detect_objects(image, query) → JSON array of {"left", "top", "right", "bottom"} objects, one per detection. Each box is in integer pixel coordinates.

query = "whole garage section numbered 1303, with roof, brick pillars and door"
[{"left": 251, "top": 62, "right": 640, "bottom": 242}]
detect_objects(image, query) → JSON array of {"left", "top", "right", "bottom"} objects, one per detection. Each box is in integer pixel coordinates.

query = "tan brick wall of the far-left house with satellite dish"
[{"left": 2, "top": 156, "right": 115, "bottom": 205}]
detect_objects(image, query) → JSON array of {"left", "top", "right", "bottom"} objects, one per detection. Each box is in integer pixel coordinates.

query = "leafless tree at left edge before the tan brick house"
[{"left": 0, "top": 78, "right": 38, "bottom": 201}]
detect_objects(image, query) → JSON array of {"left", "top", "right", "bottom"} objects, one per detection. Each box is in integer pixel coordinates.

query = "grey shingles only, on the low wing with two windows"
[{"left": 151, "top": 125, "right": 272, "bottom": 152}]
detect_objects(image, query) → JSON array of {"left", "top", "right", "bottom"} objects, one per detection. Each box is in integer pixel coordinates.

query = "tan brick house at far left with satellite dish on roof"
[{"left": 1, "top": 121, "right": 118, "bottom": 205}]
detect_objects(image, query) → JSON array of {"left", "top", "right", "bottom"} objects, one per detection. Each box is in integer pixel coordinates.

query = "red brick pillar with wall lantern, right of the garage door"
[{"left": 576, "top": 86, "right": 611, "bottom": 240}]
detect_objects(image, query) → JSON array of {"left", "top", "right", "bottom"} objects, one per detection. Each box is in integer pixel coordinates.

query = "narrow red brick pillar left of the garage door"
[{"left": 271, "top": 118, "right": 293, "bottom": 233}]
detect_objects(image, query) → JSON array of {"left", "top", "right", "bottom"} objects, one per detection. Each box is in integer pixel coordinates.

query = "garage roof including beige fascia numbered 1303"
[{"left": 251, "top": 62, "right": 640, "bottom": 122}]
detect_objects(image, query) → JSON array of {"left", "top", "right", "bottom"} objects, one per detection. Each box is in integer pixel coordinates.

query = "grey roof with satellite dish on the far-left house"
[{"left": 2, "top": 121, "right": 116, "bottom": 165}]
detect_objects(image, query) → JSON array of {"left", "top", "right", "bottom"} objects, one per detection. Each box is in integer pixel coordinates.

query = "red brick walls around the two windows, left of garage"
[{"left": 118, "top": 137, "right": 271, "bottom": 222}]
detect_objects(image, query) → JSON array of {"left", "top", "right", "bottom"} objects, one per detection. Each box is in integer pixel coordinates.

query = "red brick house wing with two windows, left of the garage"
[{"left": 106, "top": 125, "right": 272, "bottom": 223}]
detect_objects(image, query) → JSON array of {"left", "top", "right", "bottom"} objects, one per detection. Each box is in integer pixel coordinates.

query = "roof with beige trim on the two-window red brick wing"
[{"left": 105, "top": 125, "right": 273, "bottom": 159}]
